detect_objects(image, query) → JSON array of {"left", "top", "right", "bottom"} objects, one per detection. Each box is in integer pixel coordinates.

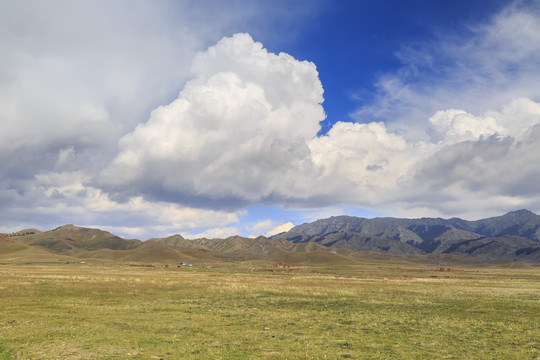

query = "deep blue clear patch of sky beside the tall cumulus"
[{"left": 253, "top": 0, "right": 510, "bottom": 133}]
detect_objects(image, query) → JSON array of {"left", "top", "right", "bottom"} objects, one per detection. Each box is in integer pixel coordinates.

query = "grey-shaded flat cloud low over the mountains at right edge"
[{"left": 404, "top": 118, "right": 540, "bottom": 217}]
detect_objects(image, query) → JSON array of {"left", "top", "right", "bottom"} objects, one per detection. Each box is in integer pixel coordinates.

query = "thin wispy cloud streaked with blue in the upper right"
[{"left": 352, "top": 2, "right": 540, "bottom": 139}]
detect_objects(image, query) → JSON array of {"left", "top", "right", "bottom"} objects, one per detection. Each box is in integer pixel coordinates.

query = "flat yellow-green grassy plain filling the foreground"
[{"left": 0, "top": 263, "right": 540, "bottom": 360}]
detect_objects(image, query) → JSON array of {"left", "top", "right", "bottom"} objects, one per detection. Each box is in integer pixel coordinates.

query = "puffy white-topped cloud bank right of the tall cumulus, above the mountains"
[{"left": 309, "top": 99, "right": 540, "bottom": 218}]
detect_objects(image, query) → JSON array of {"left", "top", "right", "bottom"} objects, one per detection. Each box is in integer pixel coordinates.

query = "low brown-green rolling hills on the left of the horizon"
[{"left": 4, "top": 225, "right": 362, "bottom": 264}]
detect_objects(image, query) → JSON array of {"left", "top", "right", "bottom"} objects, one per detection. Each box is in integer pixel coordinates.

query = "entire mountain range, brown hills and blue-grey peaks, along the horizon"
[{"left": 0, "top": 210, "right": 540, "bottom": 264}]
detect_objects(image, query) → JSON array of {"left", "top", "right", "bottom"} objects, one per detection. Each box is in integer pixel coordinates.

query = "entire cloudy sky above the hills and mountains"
[{"left": 0, "top": 0, "right": 540, "bottom": 240}]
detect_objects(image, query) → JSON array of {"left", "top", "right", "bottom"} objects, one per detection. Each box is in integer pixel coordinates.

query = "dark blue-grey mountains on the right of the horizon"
[{"left": 273, "top": 210, "right": 540, "bottom": 263}]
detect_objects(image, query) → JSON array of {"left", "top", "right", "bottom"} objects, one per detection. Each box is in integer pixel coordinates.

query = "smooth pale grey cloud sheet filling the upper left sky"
[{"left": 0, "top": 1, "right": 219, "bottom": 207}]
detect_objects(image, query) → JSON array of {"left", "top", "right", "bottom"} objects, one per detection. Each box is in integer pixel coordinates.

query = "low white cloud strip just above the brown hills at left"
[{"left": 0, "top": 171, "right": 245, "bottom": 239}]
